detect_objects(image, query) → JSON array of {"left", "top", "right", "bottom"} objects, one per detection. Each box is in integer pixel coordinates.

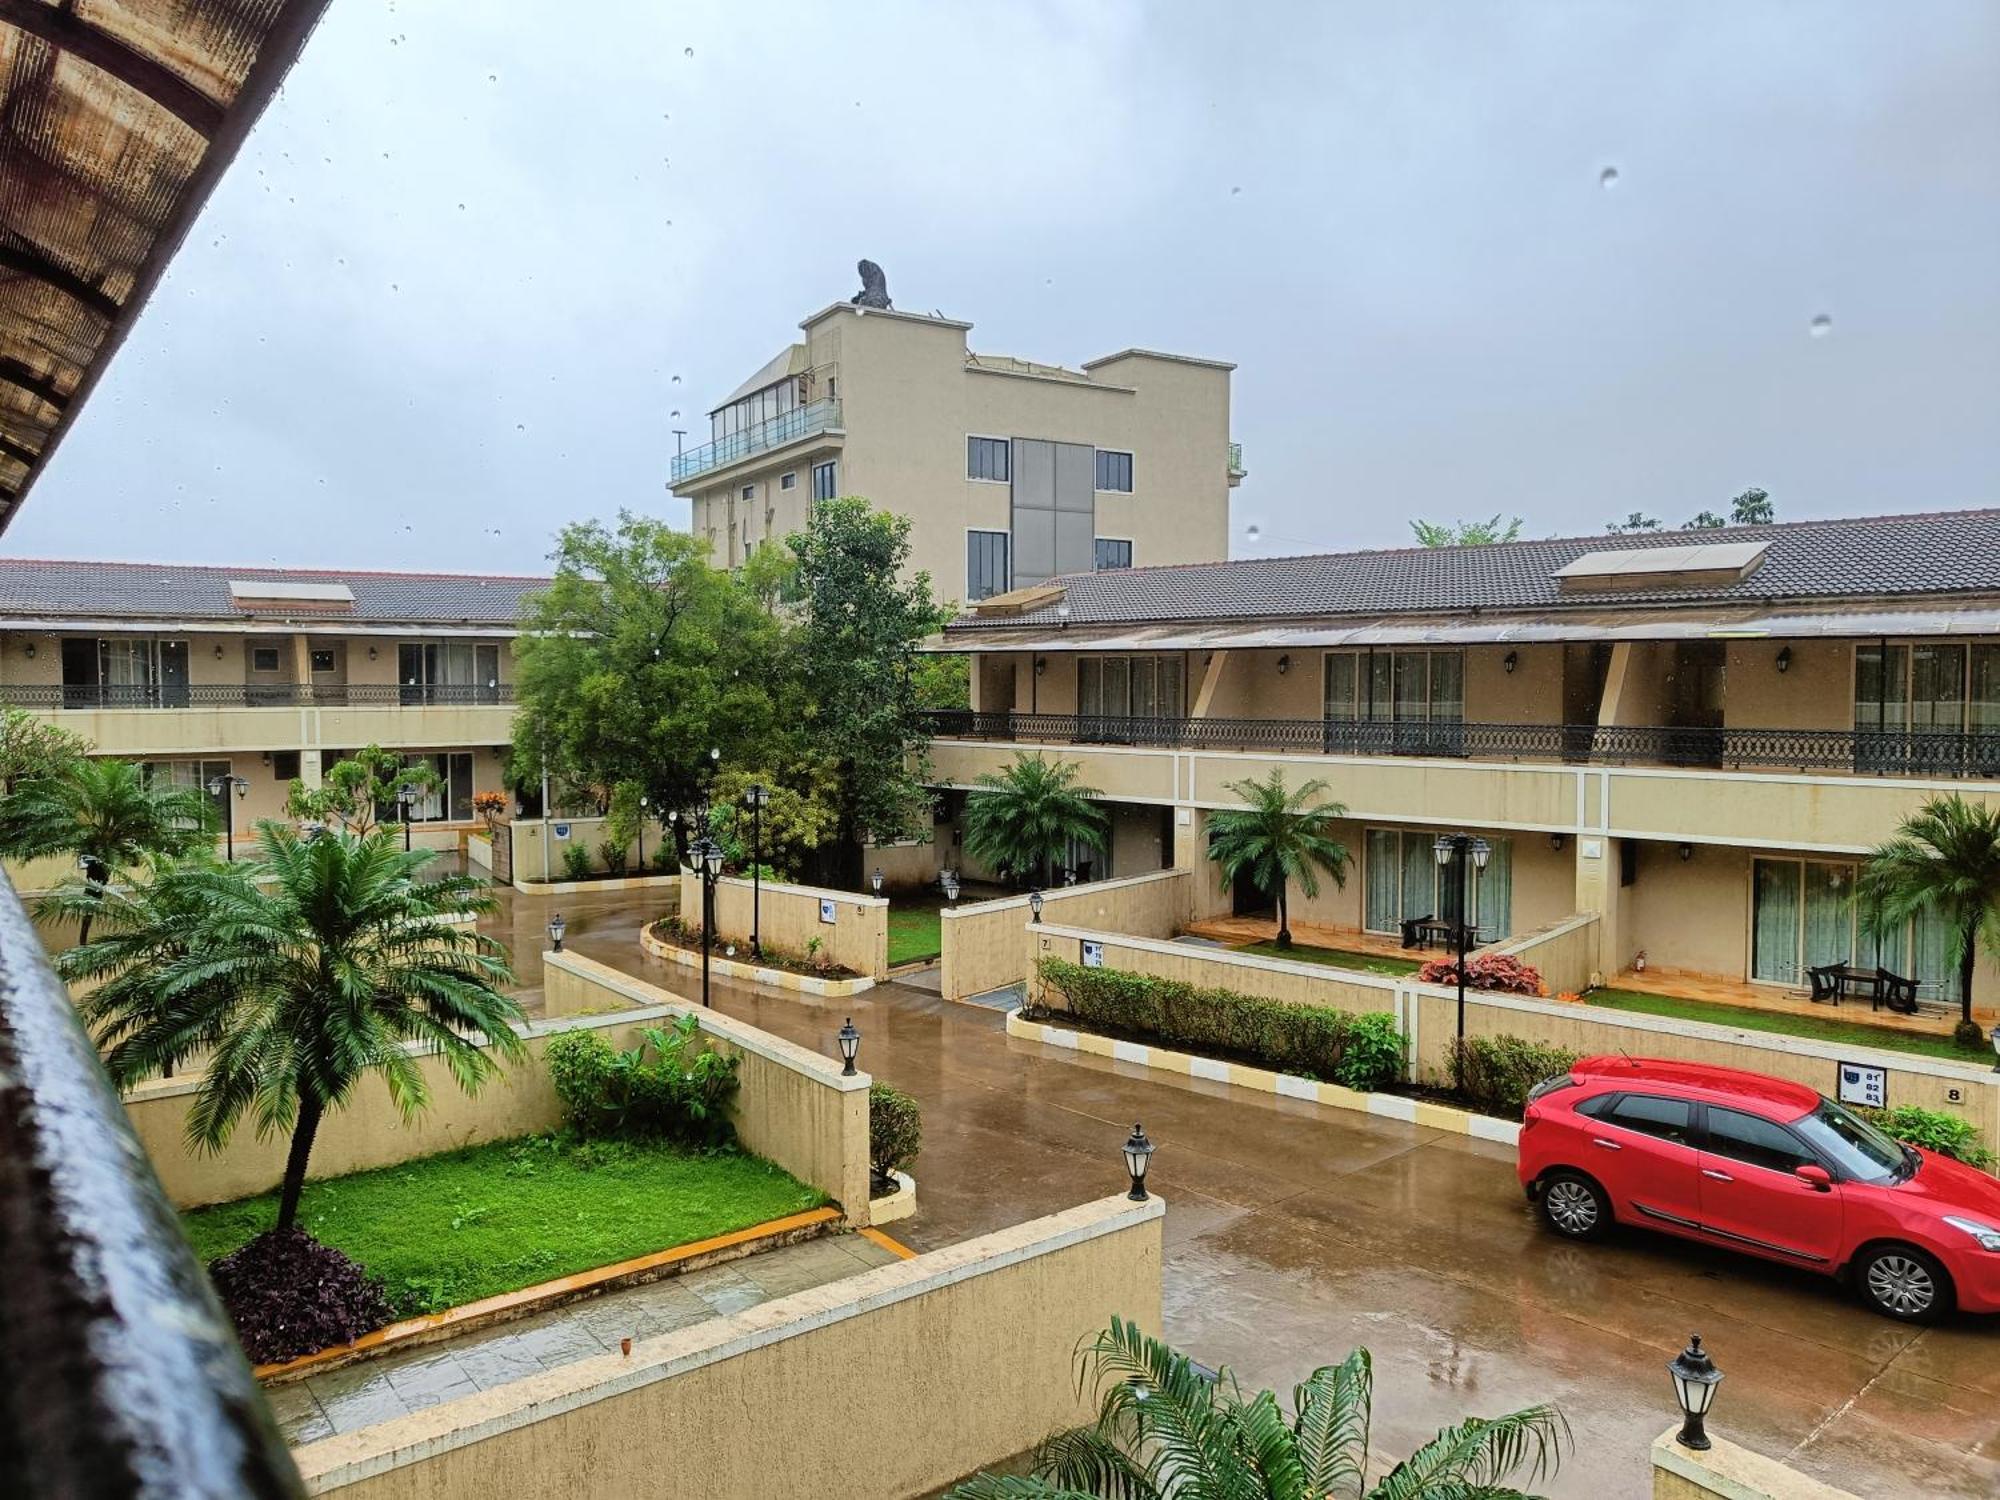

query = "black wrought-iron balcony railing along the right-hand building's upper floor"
[{"left": 928, "top": 708, "right": 2000, "bottom": 776}]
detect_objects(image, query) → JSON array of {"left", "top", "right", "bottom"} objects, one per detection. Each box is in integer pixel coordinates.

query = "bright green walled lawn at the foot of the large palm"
[{"left": 184, "top": 1136, "right": 826, "bottom": 1318}]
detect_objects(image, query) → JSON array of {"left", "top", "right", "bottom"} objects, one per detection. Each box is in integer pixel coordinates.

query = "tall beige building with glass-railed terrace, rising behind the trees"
[{"left": 672, "top": 302, "right": 1244, "bottom": 600}]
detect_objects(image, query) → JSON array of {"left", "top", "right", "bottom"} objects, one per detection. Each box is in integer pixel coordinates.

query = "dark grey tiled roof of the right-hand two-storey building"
[{"left": 952, "top": 510, "right": 2000, "bottom": 630}]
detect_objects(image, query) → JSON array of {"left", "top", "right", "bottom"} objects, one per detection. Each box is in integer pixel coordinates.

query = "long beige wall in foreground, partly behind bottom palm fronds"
[{"left": 294, "top": 1196, "right": 1164, "bottom": 1500}]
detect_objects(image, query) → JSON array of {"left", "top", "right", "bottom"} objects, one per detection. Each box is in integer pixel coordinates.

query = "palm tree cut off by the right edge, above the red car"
[{"left": 1860, "top": 792, "right": 2000, "bottom": 1046}]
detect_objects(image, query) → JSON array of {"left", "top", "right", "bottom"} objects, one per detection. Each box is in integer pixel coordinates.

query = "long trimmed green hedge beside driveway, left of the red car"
[{"left": 1038, "top": 958, "right": 1404, "bottom": 1090}]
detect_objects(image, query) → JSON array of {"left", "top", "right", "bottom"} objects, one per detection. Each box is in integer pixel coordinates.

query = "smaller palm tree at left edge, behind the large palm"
[{"left": 0, "top": 758, "right": 214, "bottom": 942}]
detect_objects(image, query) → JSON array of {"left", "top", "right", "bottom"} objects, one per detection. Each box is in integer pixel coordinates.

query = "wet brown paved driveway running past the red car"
[{"left": 488, "top": 896, "right": 2000, "bottom": 1500}]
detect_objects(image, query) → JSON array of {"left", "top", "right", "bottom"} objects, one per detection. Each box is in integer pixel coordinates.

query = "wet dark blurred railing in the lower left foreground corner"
[{"left": 0, "top": 878, "right": 304, "bottom": 1500}]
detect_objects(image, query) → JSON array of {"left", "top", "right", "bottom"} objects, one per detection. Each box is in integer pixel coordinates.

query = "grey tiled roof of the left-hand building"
[{"left": 0, "top": 558, "right": 548, "bottom": 626}]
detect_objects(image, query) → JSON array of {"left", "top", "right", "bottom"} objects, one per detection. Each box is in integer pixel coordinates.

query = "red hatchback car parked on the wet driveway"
[{"left": 1520, "top": 1056, "right": 2000, "bottom": 1322}]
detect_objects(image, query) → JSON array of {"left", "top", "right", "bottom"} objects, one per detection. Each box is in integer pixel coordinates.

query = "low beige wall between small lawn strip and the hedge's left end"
[{"left": 938, "top": 870, "right": 1194, "bottom": 1000}]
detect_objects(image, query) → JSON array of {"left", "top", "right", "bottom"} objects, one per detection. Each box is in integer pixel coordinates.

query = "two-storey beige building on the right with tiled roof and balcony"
[{"left": 932, "top": 510, "right": 2000, "bottom": 1016}]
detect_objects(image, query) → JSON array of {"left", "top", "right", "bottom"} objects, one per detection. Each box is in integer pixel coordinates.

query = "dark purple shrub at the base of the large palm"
[{"left": 208, "top": 1228, "right": 390, "bottom": 1364}]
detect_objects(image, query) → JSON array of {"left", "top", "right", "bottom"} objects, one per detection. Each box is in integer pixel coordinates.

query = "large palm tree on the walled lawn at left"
[{"left": 56, "top": 822, "right": 522, "bottom": 1230}]
